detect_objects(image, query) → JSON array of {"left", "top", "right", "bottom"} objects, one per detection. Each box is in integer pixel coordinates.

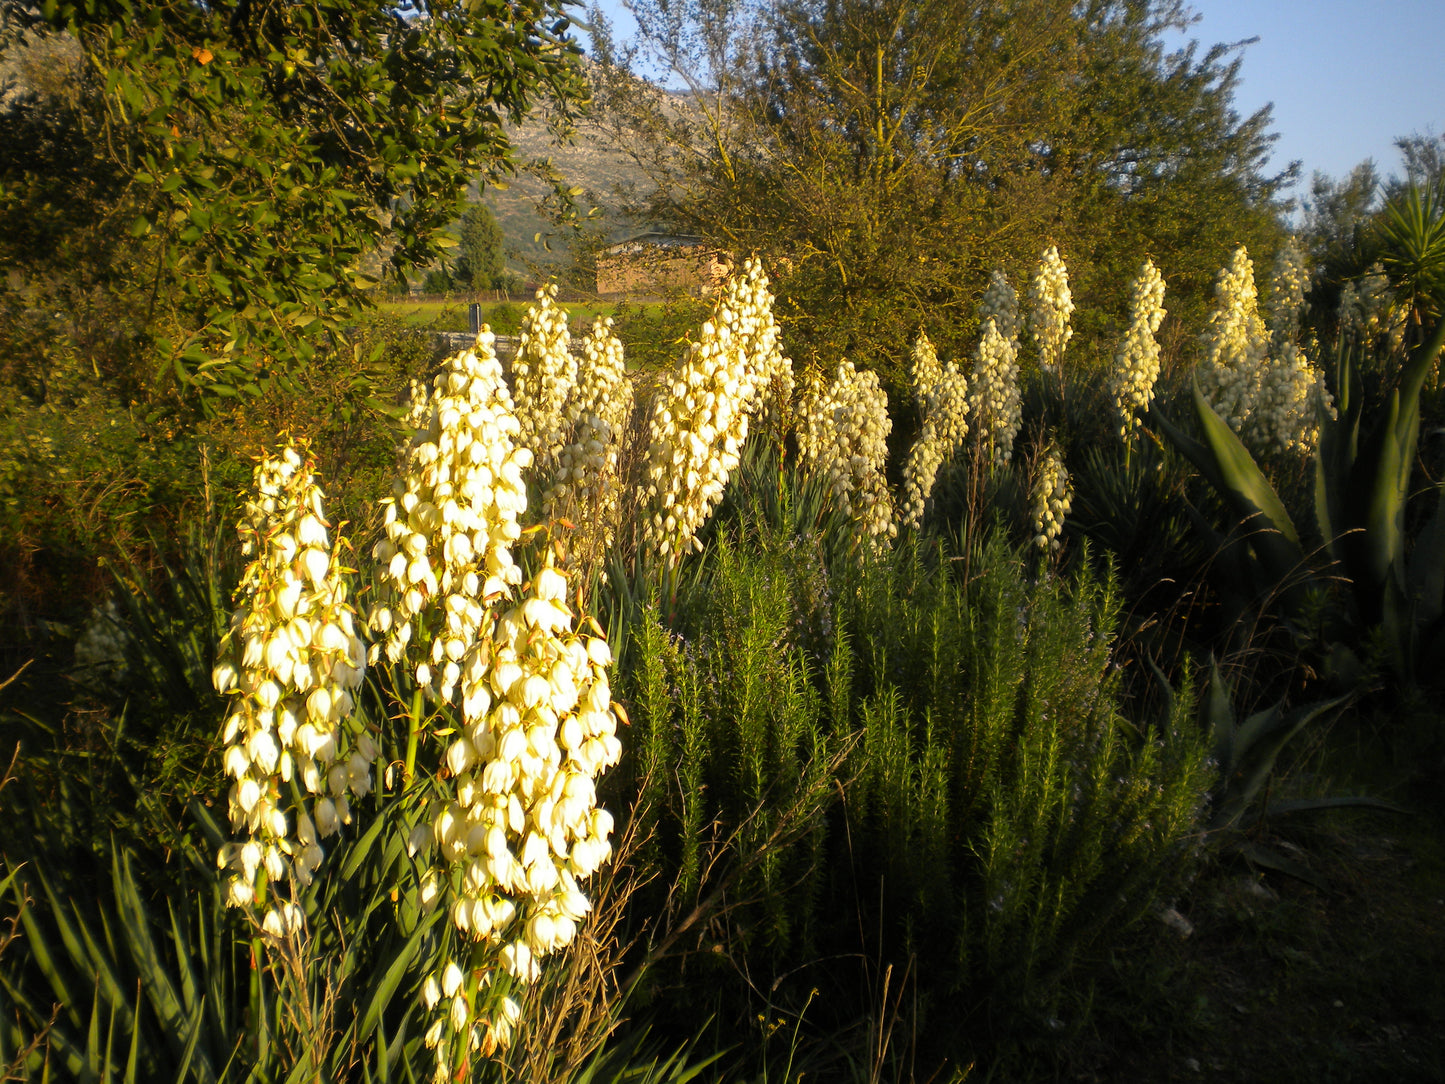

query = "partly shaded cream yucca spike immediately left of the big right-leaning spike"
[{"left": 542, "top": 317, "right": 633, "bottom": 546}]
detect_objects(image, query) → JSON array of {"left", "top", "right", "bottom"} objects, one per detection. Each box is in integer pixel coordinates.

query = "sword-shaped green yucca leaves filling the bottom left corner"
[{"left": 0, "top": 806, "right": 439, "bottom": 1081}]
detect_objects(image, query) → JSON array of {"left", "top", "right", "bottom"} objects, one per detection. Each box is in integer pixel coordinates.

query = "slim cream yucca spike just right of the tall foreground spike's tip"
[{"left": 512, "top": 282, "right": 577, "bottom": 477}]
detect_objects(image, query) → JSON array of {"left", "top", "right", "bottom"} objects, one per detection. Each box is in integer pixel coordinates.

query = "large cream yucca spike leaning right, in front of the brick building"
[{"left": 643, "top": 276, "right": 759, "bottom": 565}]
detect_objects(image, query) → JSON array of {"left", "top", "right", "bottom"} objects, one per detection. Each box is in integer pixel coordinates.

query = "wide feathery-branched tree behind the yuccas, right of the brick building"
[{"left": 592, "top": 0, "right": 1290, "bottom": 389}]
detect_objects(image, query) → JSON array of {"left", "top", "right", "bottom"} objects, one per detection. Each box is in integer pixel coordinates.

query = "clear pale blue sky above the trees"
[{"left": 580, "top": 0, "right": 1445, "bottom": 206}]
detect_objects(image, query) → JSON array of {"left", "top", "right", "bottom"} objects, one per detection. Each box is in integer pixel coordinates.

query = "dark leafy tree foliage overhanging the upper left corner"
[{"left": 0, "top": 0, "right": 587, "bottom": 400}]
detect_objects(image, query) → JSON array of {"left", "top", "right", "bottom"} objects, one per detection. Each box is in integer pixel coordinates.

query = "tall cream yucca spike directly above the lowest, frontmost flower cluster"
[{"left": 368, "top": 328, "right": 532, "bottom": 700}]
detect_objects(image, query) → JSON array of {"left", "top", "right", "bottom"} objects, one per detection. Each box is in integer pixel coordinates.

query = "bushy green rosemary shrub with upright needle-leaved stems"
[{"left": 626, "top": 473, "right": 1209, "bottom": 1057}]
